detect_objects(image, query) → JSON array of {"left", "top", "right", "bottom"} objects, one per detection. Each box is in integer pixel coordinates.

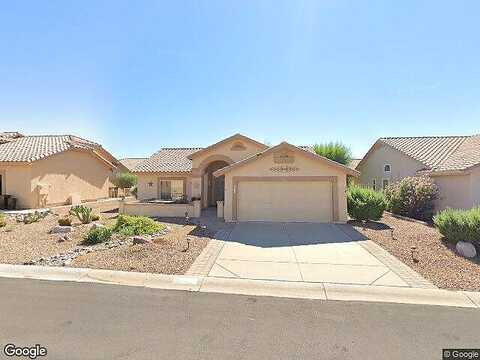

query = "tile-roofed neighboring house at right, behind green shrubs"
[{"left": 356, "top": 135, "right": 480, "bottom": 210}]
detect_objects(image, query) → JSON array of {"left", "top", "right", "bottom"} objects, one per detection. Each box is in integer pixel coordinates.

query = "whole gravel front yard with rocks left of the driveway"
[{"left": 0, "top": 213, "right": 211, "bottom": 274}]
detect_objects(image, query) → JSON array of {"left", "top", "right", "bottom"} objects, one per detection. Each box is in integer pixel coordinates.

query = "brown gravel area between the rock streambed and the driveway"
[{"left": 72, "top": 224, "right": 210, "bottom": 274}]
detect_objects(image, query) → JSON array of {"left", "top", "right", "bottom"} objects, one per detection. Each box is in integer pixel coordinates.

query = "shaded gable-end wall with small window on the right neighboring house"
[{"left": 357, "top": 145, "right": 424, "bottom": 190}]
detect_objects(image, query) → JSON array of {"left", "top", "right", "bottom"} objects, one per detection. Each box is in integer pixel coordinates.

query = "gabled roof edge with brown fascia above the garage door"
[{"left": 213, "top": 142, "right": 360, "bottom": 176}]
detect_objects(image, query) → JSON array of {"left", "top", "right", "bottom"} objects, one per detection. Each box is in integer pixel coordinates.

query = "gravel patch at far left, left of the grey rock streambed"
[{"left": 0, "top": 213, "right": 116, "bottom": 264}]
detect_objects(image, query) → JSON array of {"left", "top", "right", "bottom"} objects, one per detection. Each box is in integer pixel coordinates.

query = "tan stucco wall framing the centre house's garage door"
[{"left": 224, "top": 152, "right": 347, "bottom": 222}]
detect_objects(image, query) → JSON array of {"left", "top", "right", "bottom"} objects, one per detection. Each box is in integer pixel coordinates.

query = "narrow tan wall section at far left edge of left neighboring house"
[{"left": 0, "top": 165, "right": 33, "bottom": 209}]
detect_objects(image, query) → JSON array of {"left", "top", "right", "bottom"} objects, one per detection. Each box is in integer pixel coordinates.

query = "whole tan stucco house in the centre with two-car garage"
[{"left": 133, "top": 134, "right": 359, "bottom": 222}]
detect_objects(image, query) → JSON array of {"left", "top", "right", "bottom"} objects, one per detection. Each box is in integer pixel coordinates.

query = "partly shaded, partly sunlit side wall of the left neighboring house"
[{"left": 30, "top": 150, "right": 114, "bottom": 207}]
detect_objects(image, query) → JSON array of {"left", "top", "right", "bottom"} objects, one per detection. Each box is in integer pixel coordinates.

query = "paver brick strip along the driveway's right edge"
[{"left": 358, "top": 240, "right": 437, "bottom": 289}]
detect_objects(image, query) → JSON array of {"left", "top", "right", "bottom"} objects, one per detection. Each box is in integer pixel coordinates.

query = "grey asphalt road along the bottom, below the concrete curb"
[{"left": 0, "top": 279, "right": 480, "bottom": 360}]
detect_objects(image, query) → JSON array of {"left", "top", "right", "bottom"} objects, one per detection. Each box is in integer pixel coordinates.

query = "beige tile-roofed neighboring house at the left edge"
[{"left": 0, "top": 132, "right": 127, "bottom": 209}]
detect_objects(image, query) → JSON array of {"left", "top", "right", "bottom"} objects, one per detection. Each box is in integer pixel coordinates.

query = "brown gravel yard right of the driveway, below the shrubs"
[{"left": 351, "top": 213, "right": 480, "bottom": 291}]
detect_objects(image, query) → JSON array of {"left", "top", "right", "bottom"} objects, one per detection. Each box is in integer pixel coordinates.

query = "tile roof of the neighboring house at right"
[{"left": 379, "top": 135, "right": 480, "bottom": 171}]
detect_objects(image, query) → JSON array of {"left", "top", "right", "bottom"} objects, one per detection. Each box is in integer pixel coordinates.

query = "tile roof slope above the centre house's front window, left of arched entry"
[{"left": 133, "top": 148, "right": 201, "bottom": 172}]
